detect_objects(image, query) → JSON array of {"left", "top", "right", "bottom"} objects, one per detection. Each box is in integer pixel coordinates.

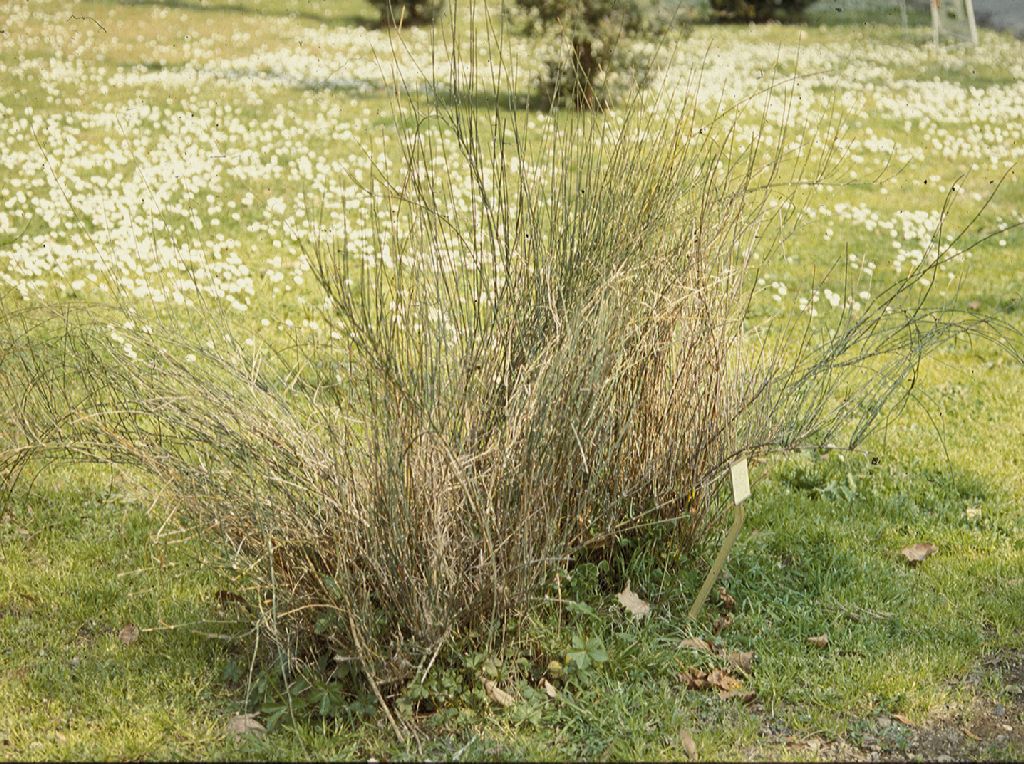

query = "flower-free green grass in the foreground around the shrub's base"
[{"left": 0, "top": 372, "right": 1024, "bottom": 759}]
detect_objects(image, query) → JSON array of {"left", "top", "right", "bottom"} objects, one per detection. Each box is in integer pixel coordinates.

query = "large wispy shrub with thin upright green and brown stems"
[{"left": 0, "top": 17, "right": 1015, "bottom": 729}]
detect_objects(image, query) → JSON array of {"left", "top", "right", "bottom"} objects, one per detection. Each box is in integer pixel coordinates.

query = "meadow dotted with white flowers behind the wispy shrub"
[{"left": 0, "top": 2, "right": 1024, "bottom": 336}]
